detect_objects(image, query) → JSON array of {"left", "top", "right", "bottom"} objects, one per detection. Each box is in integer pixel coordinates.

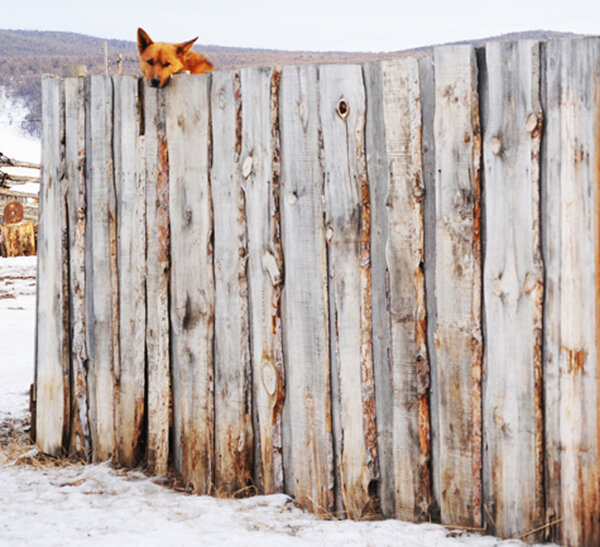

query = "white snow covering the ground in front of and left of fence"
[{"left": 0, "top": 91, "right": 552, "bottom": 547}]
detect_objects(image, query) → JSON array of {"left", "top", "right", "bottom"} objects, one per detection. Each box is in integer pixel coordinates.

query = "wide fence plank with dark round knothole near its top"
[{"left": 319, "top": 65, "right": 377, "bottom": 518}]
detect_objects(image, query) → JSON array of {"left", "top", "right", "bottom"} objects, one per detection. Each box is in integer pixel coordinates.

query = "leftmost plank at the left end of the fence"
[{"left": 35, "top": 77, "right": 70, "bottom": 456}]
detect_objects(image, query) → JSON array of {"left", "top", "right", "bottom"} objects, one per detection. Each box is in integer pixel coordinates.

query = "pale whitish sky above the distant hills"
[{"left": 0, "top": 0, "right": 600, "bottom": 51}]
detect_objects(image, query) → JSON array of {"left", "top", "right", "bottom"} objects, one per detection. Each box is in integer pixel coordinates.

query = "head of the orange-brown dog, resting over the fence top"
[{"left": 138, "top": 28, "right": 198, "bottom": 87}]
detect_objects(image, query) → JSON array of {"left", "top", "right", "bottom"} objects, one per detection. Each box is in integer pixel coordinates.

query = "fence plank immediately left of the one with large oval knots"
[{"left": 210, "top": 72, "right": 256, "bottom": 494}]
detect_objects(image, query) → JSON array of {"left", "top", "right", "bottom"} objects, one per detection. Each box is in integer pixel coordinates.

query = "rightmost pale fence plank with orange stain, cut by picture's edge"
[{"left": 544, "top": 38, "right": 600, "bottom": 545}]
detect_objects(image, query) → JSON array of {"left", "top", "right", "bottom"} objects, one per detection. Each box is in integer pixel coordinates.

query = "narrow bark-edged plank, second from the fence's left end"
[{"left": 64, "top": 78, "right": 91, "bottom": 460}]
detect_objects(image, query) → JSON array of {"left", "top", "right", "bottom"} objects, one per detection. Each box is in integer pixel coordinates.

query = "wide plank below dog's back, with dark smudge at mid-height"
[{"left": 166, "top": 74, "right": 215, "bottom": 493}]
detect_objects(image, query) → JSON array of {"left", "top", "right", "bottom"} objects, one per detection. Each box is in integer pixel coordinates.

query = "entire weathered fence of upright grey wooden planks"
[{"left": 35, "top": 38, "right": 600, "bottom": 545}]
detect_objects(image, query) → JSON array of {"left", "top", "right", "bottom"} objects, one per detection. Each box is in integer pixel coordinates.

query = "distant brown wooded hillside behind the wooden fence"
[{"left": 0, "top": 30, "right": 584, "bottom": 136}]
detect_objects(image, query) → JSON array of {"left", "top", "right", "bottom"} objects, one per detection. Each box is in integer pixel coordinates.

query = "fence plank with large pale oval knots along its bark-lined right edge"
[{"left": 240, "top": 68, "right": 284, "bottom": 494}]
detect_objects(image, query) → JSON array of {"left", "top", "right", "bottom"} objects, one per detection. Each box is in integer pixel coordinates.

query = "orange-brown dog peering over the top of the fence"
[{"left": 138, "top": 28, "right": 214, "bottom": 87}]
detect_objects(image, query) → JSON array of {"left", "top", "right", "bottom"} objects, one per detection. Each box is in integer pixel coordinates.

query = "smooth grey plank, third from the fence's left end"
[{"left": 86, "top": 76, "right": 119, "bottom": 461}]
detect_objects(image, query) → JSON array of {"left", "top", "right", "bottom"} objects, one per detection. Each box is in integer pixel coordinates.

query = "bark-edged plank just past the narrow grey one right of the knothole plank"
[{"left": 382, "top": 59, "right": 431, "bottom": 520}]
